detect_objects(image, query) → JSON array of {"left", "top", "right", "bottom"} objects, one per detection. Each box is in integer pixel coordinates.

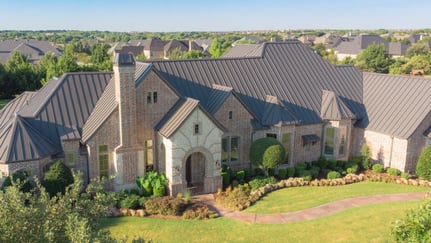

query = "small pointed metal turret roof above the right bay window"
[{"left": 320, "top": 90, "right": 355, "bottom": 120}]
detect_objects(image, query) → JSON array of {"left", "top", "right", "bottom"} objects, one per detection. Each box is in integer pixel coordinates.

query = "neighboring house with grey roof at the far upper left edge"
[{"left": 0, "top": 40, "right": 61, "bottom": 63}]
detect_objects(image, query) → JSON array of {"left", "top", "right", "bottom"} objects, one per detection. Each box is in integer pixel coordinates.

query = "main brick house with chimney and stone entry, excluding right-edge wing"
[{"left": 0, "top": 41, "right": 366, "bottom": 195}]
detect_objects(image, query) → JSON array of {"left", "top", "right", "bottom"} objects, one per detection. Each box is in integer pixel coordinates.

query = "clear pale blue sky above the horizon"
[{"left": 0, "top": 0, "right": 431, "bottom": 32}]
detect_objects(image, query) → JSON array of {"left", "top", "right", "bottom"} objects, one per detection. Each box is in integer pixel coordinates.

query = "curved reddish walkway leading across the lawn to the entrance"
[{"left": 193, "top": 192, "right": 426, "bottom": 224}]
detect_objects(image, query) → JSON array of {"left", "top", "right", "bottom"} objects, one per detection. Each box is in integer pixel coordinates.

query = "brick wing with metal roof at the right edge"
[{"left": 358, "top": 73, "right": 431, "bottom": 173}]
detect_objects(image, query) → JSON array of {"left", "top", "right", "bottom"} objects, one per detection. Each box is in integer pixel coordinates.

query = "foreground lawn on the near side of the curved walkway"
[{"left": 103, "top": 201, "right": 419, "bottom": 242}]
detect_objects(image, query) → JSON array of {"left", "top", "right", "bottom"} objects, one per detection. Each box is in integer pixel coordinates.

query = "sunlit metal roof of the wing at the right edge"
[{"left": 360, "top": 73, "right": 431, "bottom": 139}]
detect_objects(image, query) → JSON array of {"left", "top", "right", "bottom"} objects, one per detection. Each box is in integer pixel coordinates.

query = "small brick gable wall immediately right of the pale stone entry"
[{"left": 214, "top": 95, "right": 253, "bottom": 169}]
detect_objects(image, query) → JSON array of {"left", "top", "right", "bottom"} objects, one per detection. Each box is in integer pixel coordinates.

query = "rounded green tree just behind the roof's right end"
[{"left": 355, "top": 44, "right": 392, "bottom": 73}]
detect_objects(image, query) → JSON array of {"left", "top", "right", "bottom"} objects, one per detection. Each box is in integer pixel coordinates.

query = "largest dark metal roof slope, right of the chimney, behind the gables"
[{"left": 153, "top": 41, "right": 363, "bottom": 124}]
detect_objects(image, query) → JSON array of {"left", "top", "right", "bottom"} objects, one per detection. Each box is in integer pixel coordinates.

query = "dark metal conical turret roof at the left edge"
[{"left": 0, "top": 115, "right": 61, "bottom": 163}]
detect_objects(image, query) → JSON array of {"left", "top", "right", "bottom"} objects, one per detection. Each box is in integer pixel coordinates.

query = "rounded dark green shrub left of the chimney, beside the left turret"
[{"left": 42, "top": 160, "right": 73, "bottom": 197}]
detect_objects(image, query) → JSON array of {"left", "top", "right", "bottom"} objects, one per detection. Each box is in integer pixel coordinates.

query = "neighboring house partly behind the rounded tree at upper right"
[{"left": 335, "top": 35, "right": 389, "bottom": 60}]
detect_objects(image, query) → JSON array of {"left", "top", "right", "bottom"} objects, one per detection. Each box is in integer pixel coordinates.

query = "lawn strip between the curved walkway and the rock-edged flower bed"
[{"left": 245, "top": 181, "right": 431, "bottom": 214}]
